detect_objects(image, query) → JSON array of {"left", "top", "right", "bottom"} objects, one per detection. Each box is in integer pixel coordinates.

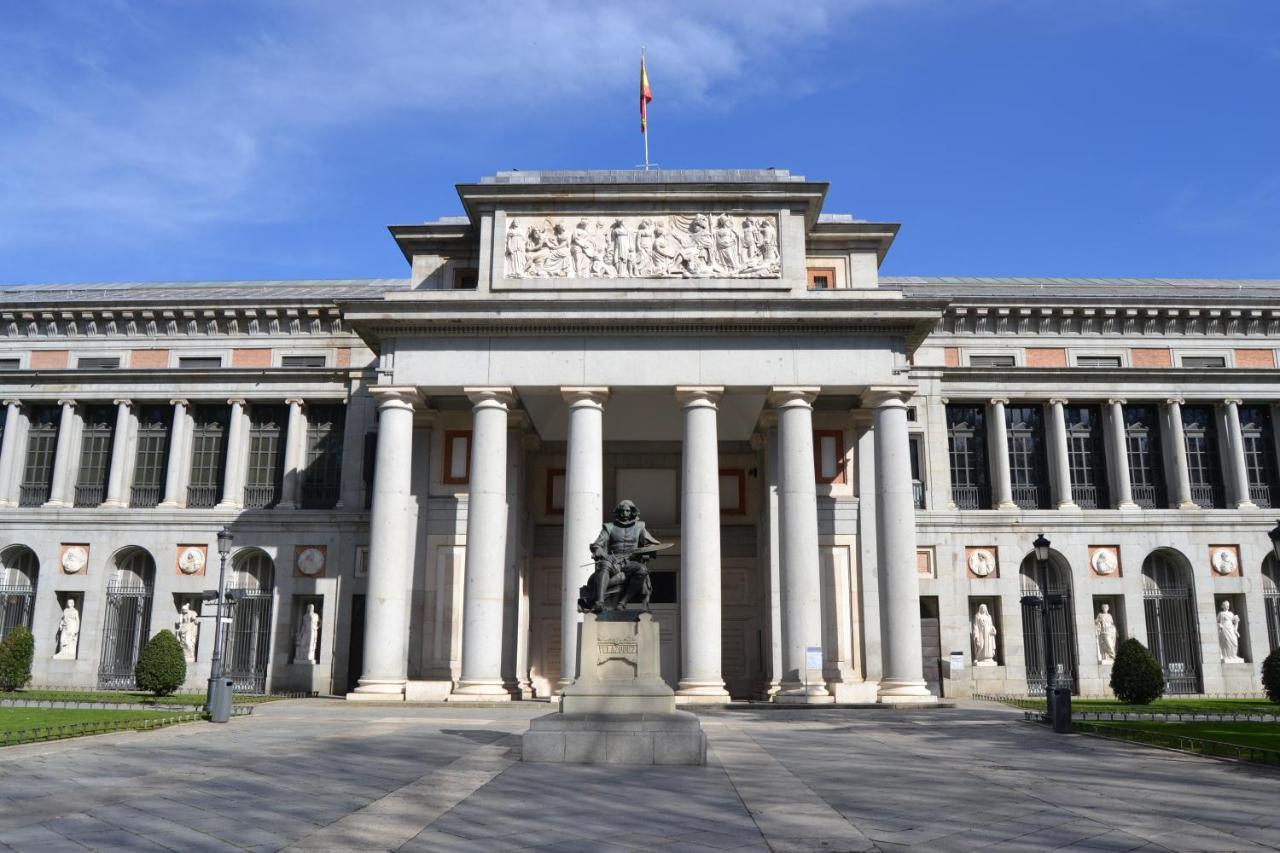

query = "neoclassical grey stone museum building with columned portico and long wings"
[{"left": 0, "top": 170, "right": 1280, "bottom": 702}]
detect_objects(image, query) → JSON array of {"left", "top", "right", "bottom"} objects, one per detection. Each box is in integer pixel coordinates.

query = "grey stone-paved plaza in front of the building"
[{"left": 0, "top": 699, "right": 1280, "bottom": 853}]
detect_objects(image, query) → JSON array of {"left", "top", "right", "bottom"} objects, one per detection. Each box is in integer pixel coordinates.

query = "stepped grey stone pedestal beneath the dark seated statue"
[{"left": 522, "top": 611, "right": 707, "bottom": 765}]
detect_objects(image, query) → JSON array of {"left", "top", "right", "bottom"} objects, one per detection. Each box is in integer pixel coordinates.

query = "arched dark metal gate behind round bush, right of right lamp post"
[{"left": 1142, "top": 555, "right": 1202, "bottom": 694}]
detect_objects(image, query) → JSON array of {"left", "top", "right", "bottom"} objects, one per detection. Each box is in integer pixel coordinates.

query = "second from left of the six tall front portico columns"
[{"left": 448, "top": 388, "right": 516, "bottom": 702}]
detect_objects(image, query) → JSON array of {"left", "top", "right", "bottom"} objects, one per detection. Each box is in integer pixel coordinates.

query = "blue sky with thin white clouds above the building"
[{"left": 0, "top": 0, "right": 1280, "bottom": 283}]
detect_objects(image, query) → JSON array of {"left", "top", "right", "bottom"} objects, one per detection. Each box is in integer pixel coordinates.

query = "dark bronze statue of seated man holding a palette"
[{"left": 577, "top": 501, "right": 662, "bottom": 613}]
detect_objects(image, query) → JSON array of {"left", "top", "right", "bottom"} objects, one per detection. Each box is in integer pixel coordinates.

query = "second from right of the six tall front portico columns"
[{"left": 769, "top": 387, "right": 829, "bottom": 703}]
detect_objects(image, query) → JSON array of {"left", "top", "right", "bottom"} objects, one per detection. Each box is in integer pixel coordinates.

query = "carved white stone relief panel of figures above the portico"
[{"left": 503, "top": 213, "right": 782, "bottom": 278}]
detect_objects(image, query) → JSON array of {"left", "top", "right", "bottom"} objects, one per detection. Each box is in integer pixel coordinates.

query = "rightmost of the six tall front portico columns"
[{"left": 863, "top": 387, "right": 936, "bottom": 703}]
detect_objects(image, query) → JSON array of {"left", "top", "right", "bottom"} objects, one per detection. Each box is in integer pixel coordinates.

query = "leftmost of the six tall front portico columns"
[{"left": 348, "top": 386, "right": 421, "bottom": 699}]
